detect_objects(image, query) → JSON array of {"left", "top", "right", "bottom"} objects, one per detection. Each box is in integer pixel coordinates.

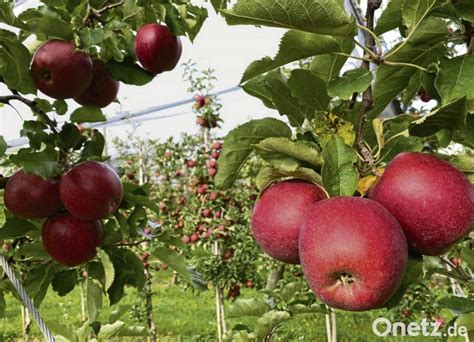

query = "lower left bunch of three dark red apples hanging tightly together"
[{"left": 4, "top": 161, "right": 123, "bottom": 267}]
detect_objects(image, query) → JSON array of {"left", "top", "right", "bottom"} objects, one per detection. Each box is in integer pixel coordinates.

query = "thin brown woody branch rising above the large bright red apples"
[{"left": 356, "top": 0, "right": 382, "bottom": 173}]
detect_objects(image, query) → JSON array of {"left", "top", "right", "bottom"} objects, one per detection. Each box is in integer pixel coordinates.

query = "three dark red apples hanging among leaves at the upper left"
[{"left": 30, "top": 23, "right": 182, "bottom": 103}]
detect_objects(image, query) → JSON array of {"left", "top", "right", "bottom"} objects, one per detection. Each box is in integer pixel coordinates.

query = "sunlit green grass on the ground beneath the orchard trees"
[{"left": 0, "top": 271, "right": 448, "bottom": 342}]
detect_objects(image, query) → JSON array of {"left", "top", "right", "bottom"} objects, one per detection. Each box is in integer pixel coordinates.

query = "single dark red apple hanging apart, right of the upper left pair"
[{"left": 135, "top": 23, "right": 182, "bottom": 75}]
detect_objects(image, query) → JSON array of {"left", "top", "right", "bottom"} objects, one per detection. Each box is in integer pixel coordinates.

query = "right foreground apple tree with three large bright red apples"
[{"left": 213, "top": 0, "right": 474, "bottom": 340}]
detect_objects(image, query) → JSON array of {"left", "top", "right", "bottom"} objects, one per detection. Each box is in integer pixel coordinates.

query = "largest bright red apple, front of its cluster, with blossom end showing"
[{"left": 299, "top": 197, "right": 408, "bottom": 311}]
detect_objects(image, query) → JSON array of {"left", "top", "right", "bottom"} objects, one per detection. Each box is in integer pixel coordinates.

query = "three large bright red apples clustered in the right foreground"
[{"left": 252, "top": 152, "right": 474, "bottom": 311}]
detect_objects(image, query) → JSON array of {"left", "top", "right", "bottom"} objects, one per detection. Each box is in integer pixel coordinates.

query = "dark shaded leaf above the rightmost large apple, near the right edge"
[{"left": 409, "top": 97, "right": 466, "bottom": 137}]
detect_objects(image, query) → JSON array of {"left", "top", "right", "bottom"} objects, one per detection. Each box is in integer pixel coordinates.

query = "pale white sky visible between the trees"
[{"left": 0, "top": 1, "right": 284, "bottom": 148}]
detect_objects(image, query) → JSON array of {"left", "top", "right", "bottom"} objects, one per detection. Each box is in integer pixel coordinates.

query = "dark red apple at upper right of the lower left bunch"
[{"left": 59, "top": 161, "right": 123, "bottom": 221}]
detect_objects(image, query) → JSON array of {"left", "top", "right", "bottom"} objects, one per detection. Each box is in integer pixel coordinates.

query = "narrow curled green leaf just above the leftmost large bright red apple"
[{"left": 256, "top": 167, "right": 323, "bottom": 192}]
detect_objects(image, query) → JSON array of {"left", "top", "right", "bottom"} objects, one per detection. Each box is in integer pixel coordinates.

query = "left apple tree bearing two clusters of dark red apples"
[{"left": 0, "top": 0, "right": 207, "bottom": 340}]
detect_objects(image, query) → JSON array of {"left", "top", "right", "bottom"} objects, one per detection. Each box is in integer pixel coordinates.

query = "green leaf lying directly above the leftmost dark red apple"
[{"left": 10, "top": 147, "right": 61, "bottom": 179}]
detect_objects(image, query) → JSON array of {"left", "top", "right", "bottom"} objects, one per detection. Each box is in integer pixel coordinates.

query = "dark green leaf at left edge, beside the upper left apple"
[{"left": 0, "top": 29, "right": 36, "bottom": 94}]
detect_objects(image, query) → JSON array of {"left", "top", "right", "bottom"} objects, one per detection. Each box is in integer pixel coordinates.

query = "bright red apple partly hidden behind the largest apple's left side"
[{"left": 252, "top": 180, "right": 327, "bottom": 264}]
